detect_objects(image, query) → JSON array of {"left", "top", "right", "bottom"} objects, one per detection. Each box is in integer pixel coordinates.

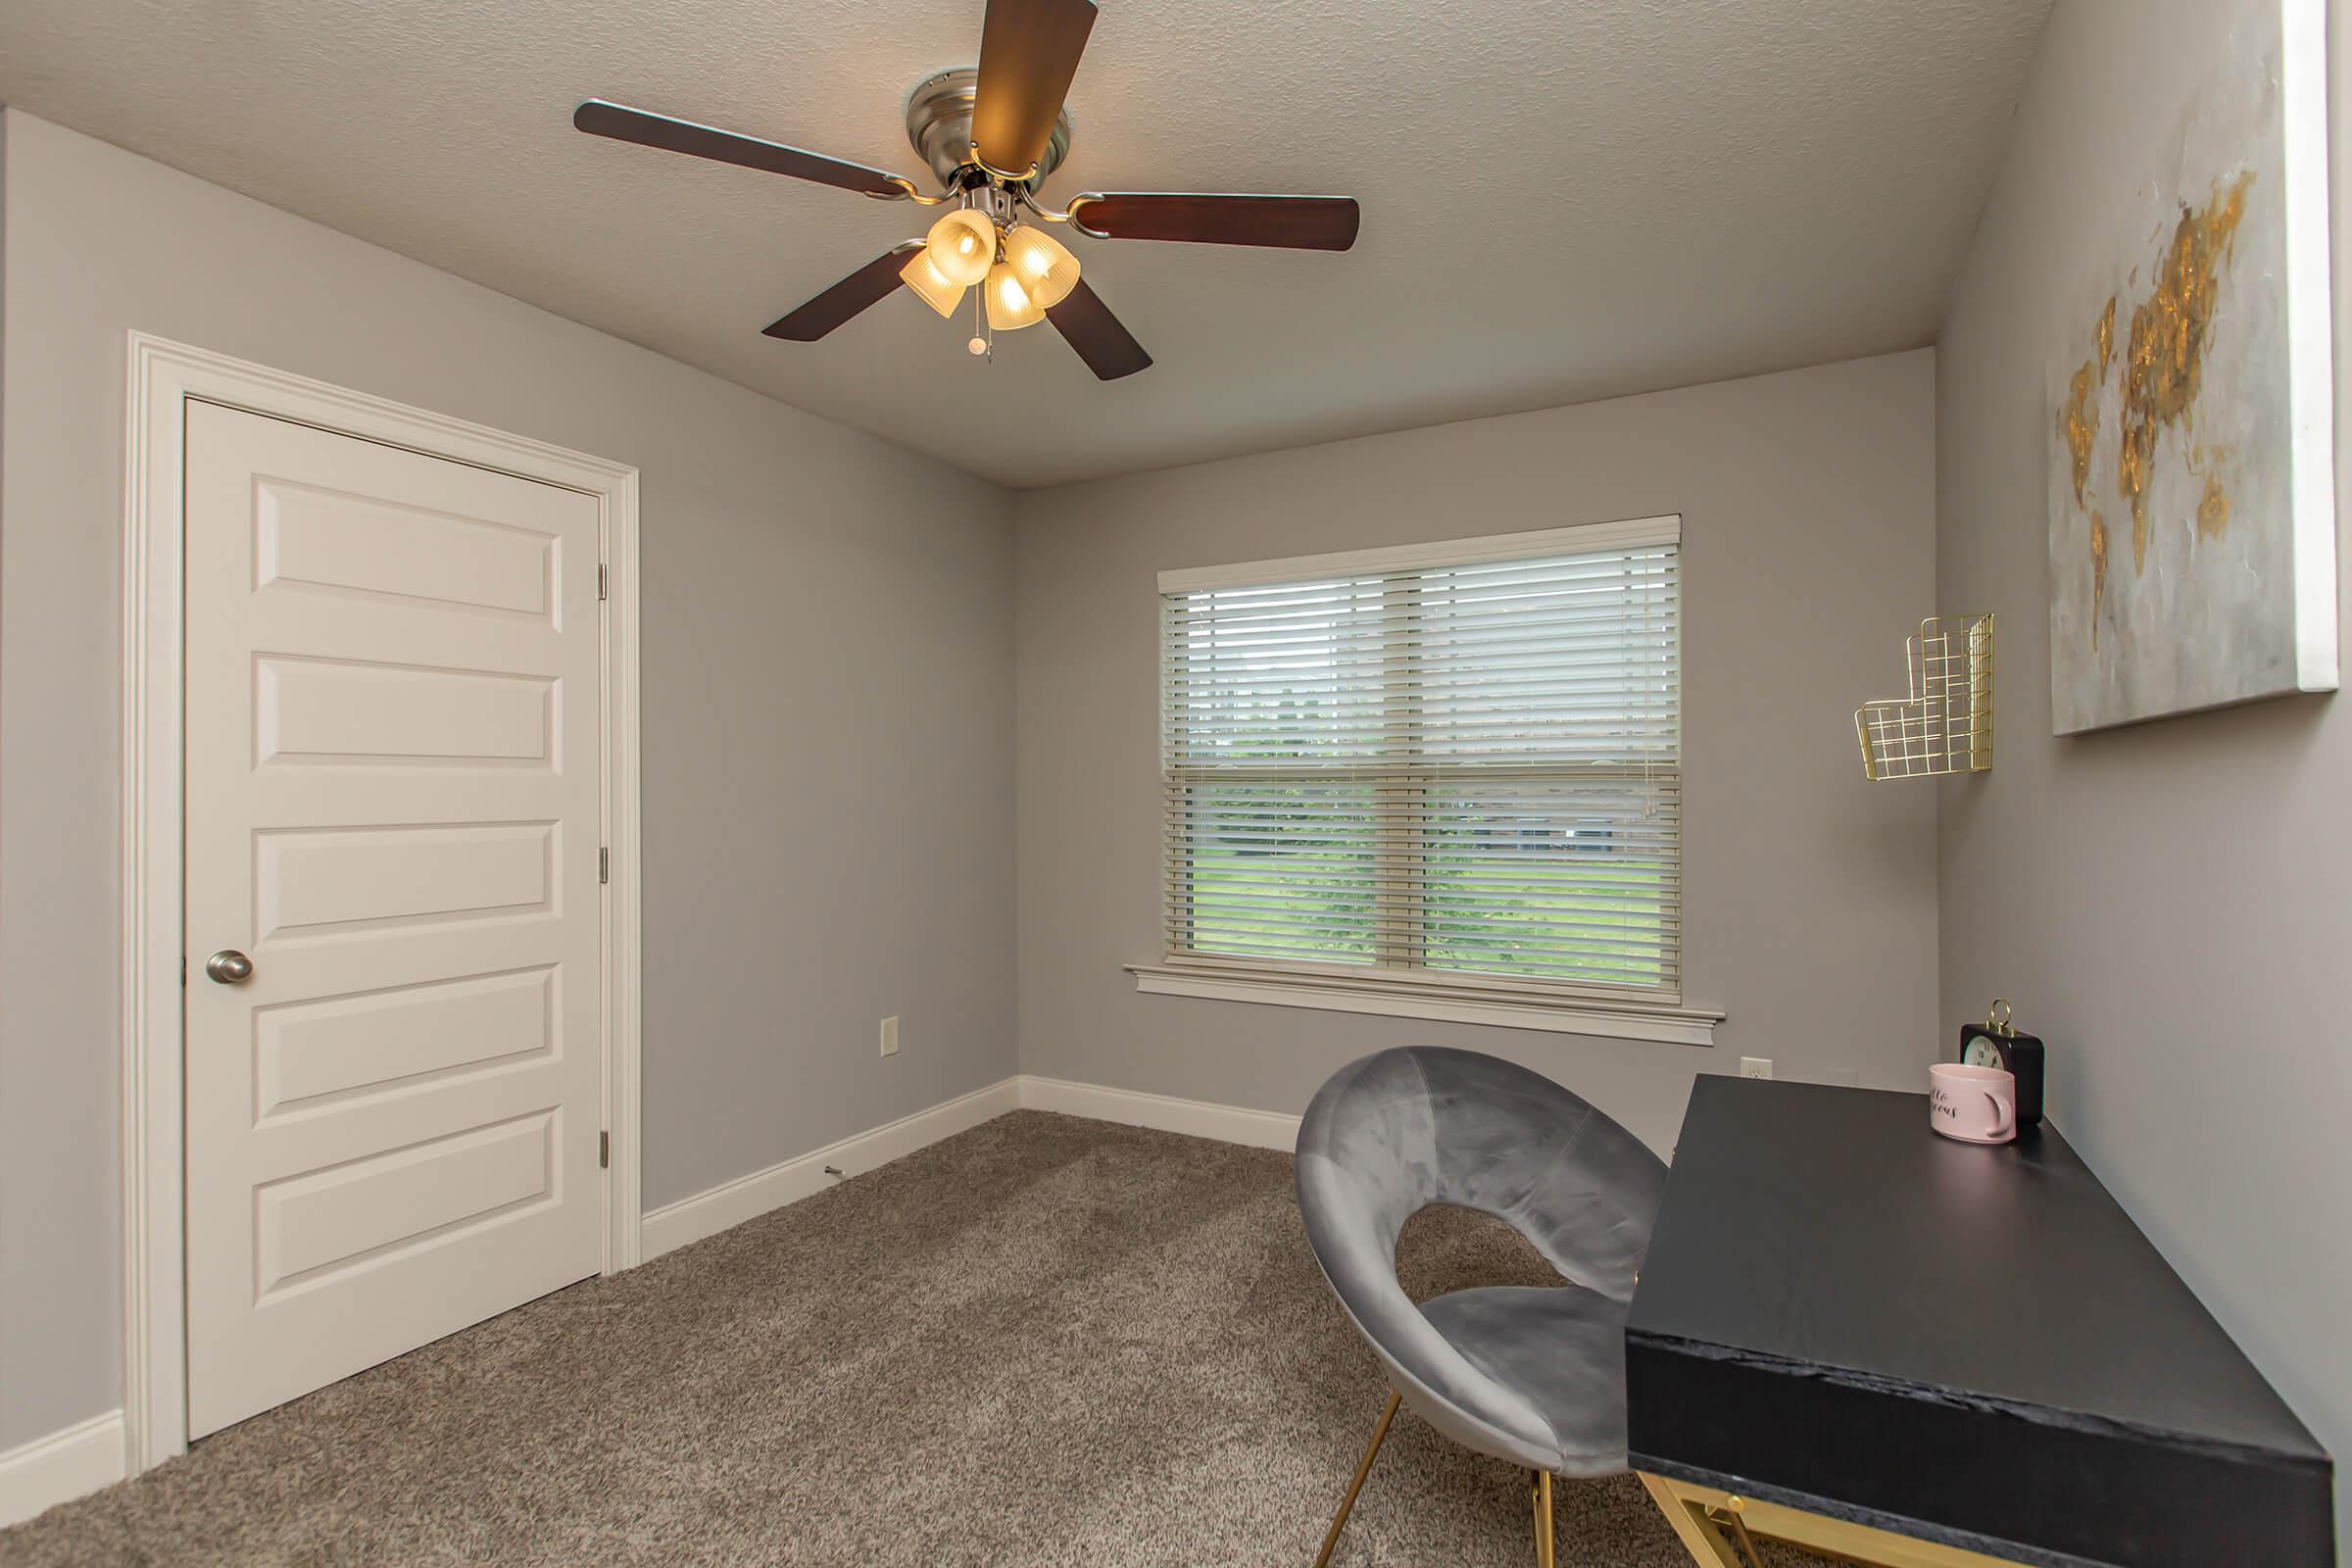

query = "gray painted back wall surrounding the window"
[{"left": 1016, "top": 350, "right": 1938, "bottom": 1165}]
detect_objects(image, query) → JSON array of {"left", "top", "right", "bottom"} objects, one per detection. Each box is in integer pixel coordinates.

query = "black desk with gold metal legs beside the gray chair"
[{"left": 1625, "top": 1077, "right": 2340, "bottom": 1568}]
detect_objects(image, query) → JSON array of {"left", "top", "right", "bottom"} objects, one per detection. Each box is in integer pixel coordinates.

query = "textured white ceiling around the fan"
[{"left": 0, "top": 0, "right": 2051, "bottom": 487}]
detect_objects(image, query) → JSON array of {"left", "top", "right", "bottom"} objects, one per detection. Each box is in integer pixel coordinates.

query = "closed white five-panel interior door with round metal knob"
[{"left": 186, "top": 402, "right": 605, "bottom": 1437}]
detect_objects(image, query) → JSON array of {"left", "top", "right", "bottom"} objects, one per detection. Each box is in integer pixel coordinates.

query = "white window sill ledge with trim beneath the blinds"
[{"left": 1127, "top": 964, "right": 1724, "bottom": 1046}]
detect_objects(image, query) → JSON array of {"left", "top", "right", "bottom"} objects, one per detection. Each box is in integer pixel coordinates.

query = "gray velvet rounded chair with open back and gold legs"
[{"left": 1298, "top": 1049, "right": 1665, "bottom": 1568}]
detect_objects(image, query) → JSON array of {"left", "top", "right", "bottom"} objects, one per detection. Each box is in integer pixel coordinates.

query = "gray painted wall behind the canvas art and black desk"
[{"left": 1936, "top": 0, "right": 2352, "bottom": 1533}]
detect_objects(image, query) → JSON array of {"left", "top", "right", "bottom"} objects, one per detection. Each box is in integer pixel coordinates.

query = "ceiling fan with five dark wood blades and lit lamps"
[{"left": 571, "top": 0, "right": 1359, "bottom": 381}]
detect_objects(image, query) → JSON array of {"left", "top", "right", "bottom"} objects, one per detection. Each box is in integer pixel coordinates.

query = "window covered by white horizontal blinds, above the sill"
[{"left": 1159, "top": 517, "right": 1682, "bottom": 1024}]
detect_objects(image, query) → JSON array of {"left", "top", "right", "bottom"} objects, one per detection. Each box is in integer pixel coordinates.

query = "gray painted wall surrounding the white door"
[{"left": 0, "top": 113, "right": 1016, "bottom": 1448}]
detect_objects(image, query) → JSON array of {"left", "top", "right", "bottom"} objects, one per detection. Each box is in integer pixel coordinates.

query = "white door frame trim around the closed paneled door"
[{"left": 122, "top": 331, "right": 642, "bottom": 1476}]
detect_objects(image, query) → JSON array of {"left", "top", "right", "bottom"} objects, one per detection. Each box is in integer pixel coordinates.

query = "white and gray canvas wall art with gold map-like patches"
[{"left": 2046, "top": 0, "right": 2335, "bottom": 736}]
